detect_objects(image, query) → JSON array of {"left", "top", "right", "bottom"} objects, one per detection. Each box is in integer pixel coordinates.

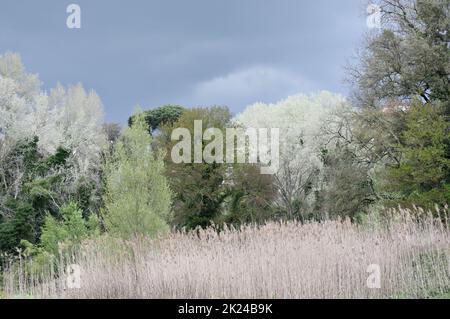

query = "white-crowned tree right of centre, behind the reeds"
[{"left": 235, "top": 91, "right": 346, "bottom": 217}]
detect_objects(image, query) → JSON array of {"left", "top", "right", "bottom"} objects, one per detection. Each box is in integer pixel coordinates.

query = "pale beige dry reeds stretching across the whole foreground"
[{"left": 4, "top": 210, "right": 450, "bottom": 298}]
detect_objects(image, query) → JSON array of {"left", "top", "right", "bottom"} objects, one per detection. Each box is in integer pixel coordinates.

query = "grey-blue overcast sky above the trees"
[{"left": 0, "top": 0, "right": 367, "bottom": 123}]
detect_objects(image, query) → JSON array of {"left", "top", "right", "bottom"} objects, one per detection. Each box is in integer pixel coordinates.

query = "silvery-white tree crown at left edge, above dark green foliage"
[{"left": 0, "top": 53, "right": 106, "bottom": 178}]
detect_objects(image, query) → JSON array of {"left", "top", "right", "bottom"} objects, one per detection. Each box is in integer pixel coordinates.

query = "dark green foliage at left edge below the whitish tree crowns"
[{"left": 0, "top": 138, "right": 98, "bottom": 253}]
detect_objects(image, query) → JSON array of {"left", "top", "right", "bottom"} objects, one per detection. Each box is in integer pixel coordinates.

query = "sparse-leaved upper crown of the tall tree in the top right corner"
[{"left": 349, "top": 0, "right": 450, "bottom": 113}]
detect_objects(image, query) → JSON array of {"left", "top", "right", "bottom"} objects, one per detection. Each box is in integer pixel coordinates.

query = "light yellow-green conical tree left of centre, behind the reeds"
[{"left": 103, "top": 113, "right": 172, "bottom": 239}]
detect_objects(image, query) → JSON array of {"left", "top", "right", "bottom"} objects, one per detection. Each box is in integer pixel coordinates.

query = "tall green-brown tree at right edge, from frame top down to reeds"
[{"left": 346, "top": 0, "right": 450, "bottom": 212}]
